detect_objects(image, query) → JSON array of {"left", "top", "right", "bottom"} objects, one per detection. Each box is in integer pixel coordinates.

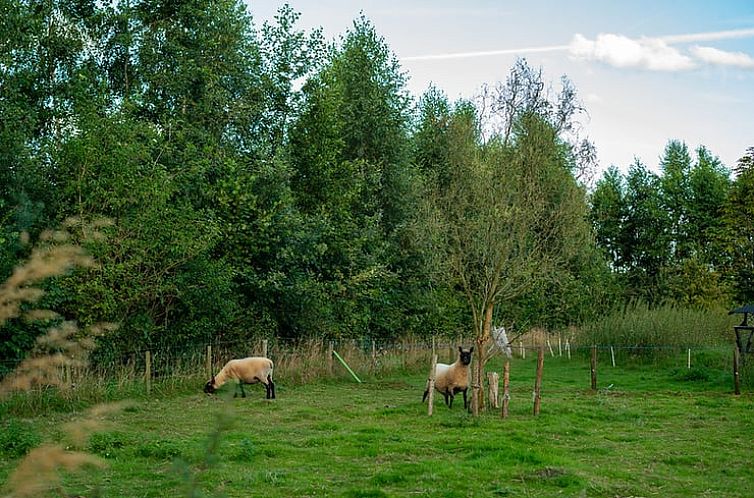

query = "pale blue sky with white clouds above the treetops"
[{"left": 246, "top": 0, "right": 754, "bottom": 177}]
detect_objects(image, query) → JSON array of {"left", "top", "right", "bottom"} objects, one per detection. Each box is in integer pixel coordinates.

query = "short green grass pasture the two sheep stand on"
[{"left": 0, "top": 357, "right": 754, "bottom": 497}]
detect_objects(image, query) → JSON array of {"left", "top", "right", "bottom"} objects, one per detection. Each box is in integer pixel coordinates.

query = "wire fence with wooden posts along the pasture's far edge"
[{"left": 0, "top": 335, "right": 740, "bottom": 412}]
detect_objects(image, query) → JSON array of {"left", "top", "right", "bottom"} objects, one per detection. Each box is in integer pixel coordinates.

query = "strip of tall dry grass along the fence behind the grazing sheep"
[{"left": 0, "top": 337, "right": 457, "bottom": 416}]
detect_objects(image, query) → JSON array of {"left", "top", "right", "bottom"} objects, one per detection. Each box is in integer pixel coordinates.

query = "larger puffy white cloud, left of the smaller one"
[{"left": 569, "top": 33, "right": 696, "bottom": 71}]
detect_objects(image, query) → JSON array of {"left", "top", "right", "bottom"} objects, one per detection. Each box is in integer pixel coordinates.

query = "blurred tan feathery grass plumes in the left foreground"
[{"left": 0, "top": 219, "right": 128, "bottom": 497}]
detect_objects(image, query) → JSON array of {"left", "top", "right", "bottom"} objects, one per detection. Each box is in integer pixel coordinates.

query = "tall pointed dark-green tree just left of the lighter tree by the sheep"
[{"left": 289, "top": 17, "right": 414, "bottom": 335}]
